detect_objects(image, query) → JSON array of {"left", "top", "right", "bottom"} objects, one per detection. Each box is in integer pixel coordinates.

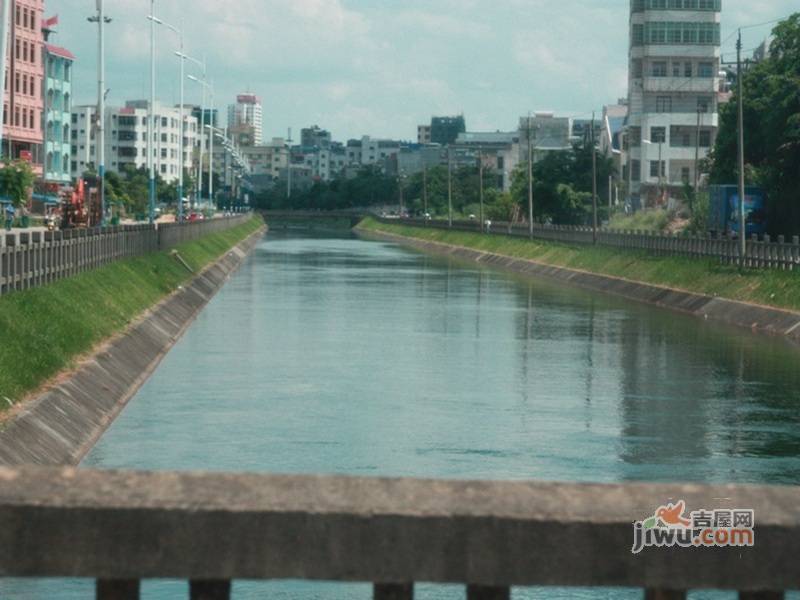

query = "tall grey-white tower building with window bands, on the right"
[{"left": 626, "top": 0, "right": 721, "bottom": 206}]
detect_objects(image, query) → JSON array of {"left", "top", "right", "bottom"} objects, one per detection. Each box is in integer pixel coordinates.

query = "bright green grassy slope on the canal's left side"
[{"left": 0, "top": 217, "right": 263, "bottom": 411}]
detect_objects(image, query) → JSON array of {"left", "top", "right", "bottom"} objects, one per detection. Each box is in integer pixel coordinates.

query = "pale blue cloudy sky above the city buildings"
[{"left": 45, "top": 0, "right": 800, "bottom": 141}]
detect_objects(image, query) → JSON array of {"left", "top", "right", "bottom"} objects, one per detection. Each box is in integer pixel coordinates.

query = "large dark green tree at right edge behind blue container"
[{"left": 710, "top": 13, "right": 800, "bottom": 235}]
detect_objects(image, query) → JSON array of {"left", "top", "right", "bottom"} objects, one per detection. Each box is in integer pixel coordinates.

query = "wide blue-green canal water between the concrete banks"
[{"left": 6, "top": 232, "right": 800, "bottom": 600}]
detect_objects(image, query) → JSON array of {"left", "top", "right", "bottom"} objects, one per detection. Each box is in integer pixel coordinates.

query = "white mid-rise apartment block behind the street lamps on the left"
[{"left": 71, "top": 100, "right": 198, "bottom": 182}]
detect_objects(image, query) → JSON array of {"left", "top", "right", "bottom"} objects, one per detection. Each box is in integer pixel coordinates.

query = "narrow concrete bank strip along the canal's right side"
[{"left": 355, "top": 228, "right": 800, "bottom": 342}]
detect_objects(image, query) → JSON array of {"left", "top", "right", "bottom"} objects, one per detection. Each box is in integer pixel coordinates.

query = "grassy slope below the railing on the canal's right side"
[{"left": 358, "top": 218, "right": 800, "bottom": 310}]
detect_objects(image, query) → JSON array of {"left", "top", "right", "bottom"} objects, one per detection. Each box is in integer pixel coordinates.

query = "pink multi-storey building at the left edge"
[{"left": 0, "top": 0, "right": 44, "bottom": 175}]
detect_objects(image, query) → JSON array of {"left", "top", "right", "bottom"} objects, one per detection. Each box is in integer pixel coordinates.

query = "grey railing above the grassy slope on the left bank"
[{"left": 0, "top": 215, "right": 250, "bottom": 295}]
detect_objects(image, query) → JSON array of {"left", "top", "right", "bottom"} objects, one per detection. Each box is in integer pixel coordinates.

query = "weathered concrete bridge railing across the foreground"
[{"left": 0, "top": 467, "right": 800, "bottom": 600}]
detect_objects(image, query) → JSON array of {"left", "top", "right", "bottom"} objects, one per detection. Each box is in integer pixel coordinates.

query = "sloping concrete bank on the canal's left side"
[{"left": 0, "top": 229, "right": 264, "bottom": 465}]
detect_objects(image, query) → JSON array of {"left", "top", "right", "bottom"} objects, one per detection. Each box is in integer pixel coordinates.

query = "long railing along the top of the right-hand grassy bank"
[{"left": 382, "top": 217, "right": 800, "bottom": 270}]
